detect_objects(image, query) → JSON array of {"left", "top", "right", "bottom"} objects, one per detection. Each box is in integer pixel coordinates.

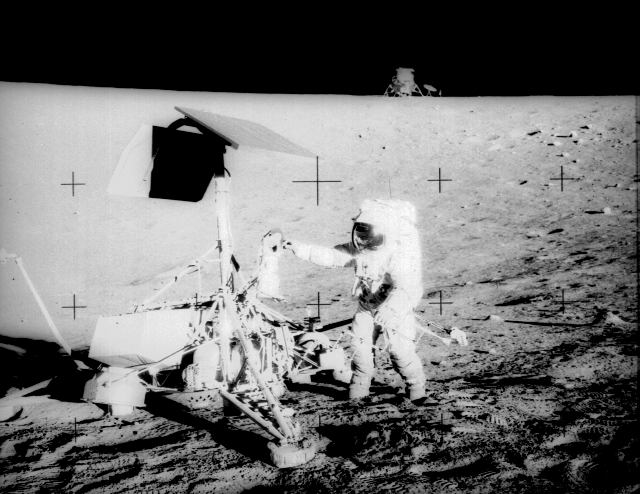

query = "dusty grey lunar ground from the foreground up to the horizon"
[{"left": 0, "top": 84, "right": 640, "bottom": 493}]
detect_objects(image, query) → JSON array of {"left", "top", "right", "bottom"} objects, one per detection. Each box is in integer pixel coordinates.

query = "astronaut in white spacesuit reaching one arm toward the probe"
[{"left": 284, "top": 200, "right": 425, "bottom": 402}]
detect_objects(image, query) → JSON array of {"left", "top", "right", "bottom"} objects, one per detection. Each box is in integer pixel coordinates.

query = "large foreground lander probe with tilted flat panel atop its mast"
[{"left": 84, "top": 108, "right": 351, "bottom": 467}]
